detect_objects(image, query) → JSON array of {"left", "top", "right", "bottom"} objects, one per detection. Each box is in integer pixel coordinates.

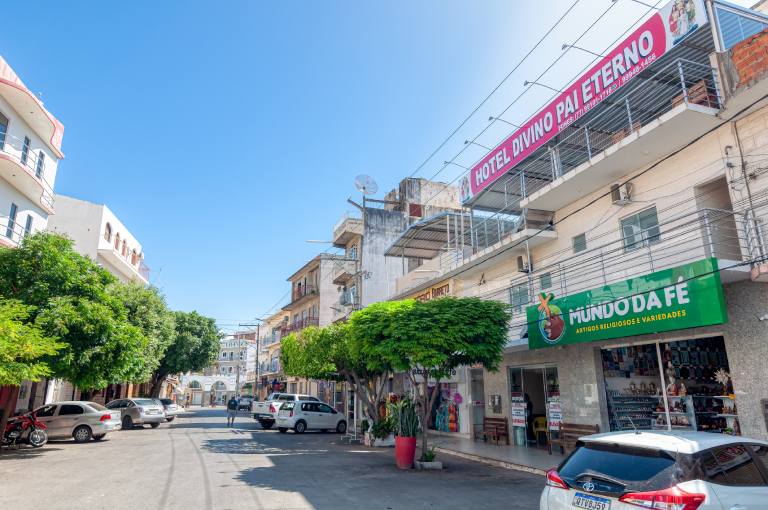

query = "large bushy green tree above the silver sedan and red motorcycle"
[{"left": 0, "top": 232, "right": 148, "bottom": 396}]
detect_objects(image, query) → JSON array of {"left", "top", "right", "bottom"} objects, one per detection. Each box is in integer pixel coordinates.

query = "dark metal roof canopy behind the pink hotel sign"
[{"left": 464, "top": 23, "right": 715, "bottom": 213}]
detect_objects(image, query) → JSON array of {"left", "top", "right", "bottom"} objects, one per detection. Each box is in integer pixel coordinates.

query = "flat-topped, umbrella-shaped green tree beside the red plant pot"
[{"left": 360, "top": 297, "right": 510, "bottom": 454}]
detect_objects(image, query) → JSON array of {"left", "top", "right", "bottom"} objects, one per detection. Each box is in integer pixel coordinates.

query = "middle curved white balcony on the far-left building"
[{"left": 0, "top": 134, "right": 53, "bottom": 214}]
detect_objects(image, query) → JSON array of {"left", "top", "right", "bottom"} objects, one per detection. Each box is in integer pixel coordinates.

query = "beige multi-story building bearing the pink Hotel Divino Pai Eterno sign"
[{"left": 389, "top": 0, "right": 768, "bottom": 454}]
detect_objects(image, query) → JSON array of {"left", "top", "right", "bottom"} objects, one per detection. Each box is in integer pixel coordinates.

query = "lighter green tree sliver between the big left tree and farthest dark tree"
[{"left": 109, "top": 283, "right": 176, "bottom": 383}]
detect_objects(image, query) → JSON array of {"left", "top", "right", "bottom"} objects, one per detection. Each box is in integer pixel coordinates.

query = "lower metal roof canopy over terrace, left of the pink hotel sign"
[{"left": 384, "top": 211, "right": 519, "bottom": 259}]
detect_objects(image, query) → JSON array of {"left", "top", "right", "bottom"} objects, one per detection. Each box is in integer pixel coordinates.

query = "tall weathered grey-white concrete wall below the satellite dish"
[{"left": 360, "top": 207, "right": 405, "bottom": 307}]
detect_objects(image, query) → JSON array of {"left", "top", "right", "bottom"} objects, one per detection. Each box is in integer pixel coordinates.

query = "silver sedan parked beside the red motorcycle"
[{"left": 35, "top": 401, "right": 120, "bottom": 443}]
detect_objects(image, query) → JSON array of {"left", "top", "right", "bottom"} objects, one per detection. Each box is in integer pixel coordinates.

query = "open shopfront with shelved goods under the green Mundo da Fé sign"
[{"left": 601, "top": 336, "right": 741, "bottom": 435}]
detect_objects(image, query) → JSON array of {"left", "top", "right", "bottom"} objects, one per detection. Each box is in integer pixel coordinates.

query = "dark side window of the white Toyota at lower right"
[{"left": 702, "top": 444, "right": 766, "bottom": 487}]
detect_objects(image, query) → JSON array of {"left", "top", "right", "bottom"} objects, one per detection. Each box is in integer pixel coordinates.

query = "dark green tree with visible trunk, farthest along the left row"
[{"left": 150, "top": 312, "right": 222, "bottom": 397}]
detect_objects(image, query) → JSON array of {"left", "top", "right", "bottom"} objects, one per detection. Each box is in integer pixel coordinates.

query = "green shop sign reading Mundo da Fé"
[{"left": 526, "top": 258, "right": 728, "bottom": 349}]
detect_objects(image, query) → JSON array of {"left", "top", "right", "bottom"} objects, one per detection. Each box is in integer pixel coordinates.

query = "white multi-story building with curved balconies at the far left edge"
[{"left": 0, "top": 57, "right": 64, "bottom": 416}]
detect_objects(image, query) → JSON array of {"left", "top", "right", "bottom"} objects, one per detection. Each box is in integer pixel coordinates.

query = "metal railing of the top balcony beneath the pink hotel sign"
[{"left": 504, "top": 59, "right": 721, "bottom": 207}]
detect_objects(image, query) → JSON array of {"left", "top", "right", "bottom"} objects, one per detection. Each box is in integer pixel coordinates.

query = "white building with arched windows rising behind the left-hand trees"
[{"left": 48, "top": 195, "right": 149, "bottom": 283}]
